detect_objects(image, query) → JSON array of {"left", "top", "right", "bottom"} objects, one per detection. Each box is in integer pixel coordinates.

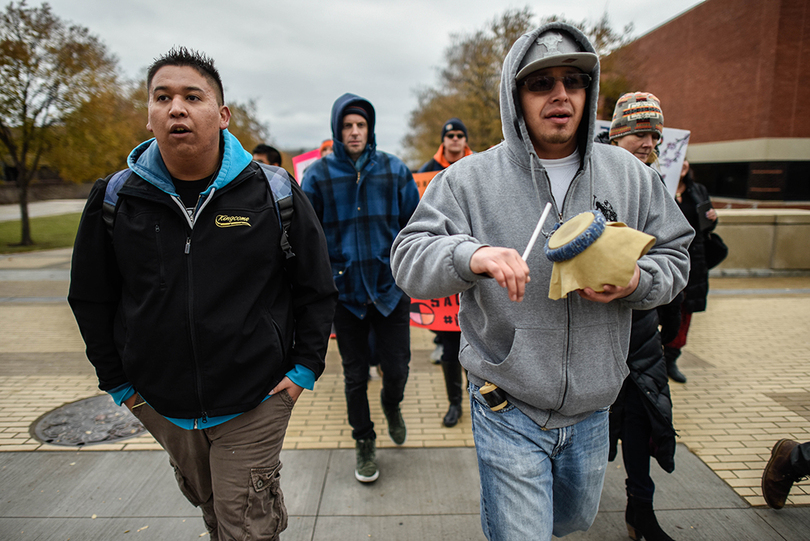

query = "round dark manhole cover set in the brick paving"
[{"left": 33, "top": 395, "right": 146, "bottom": 446}]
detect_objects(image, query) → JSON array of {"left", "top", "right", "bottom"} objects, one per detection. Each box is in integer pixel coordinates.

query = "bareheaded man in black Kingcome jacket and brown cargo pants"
[{"left": 68, "top": 48, "right": 337, "bottom": 540}]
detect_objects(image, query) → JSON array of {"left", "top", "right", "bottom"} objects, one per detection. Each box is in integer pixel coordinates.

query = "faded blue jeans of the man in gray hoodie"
[{"left": 470, "top": 384, "right": 608, "bottom": 541}]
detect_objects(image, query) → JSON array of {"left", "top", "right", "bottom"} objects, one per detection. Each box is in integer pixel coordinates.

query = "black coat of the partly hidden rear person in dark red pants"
[{"left": 678, "top": 171, "right": 717, "bottom": 313}]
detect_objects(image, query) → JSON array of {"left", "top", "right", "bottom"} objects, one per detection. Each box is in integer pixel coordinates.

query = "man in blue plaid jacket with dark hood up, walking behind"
[{"left": 301, "top": 94, "right": 419, "bottom": 483}]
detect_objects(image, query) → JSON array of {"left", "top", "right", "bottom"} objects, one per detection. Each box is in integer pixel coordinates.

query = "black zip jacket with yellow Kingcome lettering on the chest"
[{"left": 68, "top": 162, "right": 337, "bottom": 418}]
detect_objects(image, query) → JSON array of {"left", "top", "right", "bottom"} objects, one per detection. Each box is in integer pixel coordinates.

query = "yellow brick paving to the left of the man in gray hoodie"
[{"left": 0, "top": 303, "right": 473, "bottom": 451}]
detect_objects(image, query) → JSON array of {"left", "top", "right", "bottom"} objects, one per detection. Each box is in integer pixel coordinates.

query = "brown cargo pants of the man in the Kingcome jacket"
[{"left": 132, "top": 391, "right": 293, "bottom": 541}]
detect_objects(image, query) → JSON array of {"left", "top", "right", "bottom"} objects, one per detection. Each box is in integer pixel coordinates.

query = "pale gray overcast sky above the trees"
[{"left": 42, "top": 0, "right": 701, "bottom": 159}]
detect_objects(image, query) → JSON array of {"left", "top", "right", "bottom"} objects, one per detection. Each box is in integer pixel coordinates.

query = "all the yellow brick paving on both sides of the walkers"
[{"left": 0, "top": 258, "right": 810, "bottom": 505}]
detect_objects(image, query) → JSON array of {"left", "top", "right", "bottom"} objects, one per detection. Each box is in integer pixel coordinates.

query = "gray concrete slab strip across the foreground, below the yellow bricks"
[{"left": 0, "top": 445, "right": 810, "bottom": 541}]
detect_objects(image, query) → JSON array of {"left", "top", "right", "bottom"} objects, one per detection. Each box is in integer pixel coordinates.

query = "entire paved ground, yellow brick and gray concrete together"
[{"left": 0, "top": 250, "right": 810, "bottom": 540}]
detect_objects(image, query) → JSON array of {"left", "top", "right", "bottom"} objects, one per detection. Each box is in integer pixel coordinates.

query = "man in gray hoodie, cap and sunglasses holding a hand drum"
[{"left": 391, "top": 23, "right": 693, "bottom": 540}]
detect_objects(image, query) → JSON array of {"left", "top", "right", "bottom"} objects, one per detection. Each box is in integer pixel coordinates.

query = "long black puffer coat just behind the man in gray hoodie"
[{"left": 608, "top": 307, "right": 675, "bottom": 473}]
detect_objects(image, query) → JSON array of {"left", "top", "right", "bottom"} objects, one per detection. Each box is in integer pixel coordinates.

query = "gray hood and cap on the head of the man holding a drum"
[{"left": 500, "top": 22, "right": 599, "bottom": 167}]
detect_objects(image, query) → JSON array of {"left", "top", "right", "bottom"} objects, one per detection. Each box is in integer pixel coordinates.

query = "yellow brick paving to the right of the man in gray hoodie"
[{"left": 670, "top": 279, "right": 810, "bottom": 506}]
